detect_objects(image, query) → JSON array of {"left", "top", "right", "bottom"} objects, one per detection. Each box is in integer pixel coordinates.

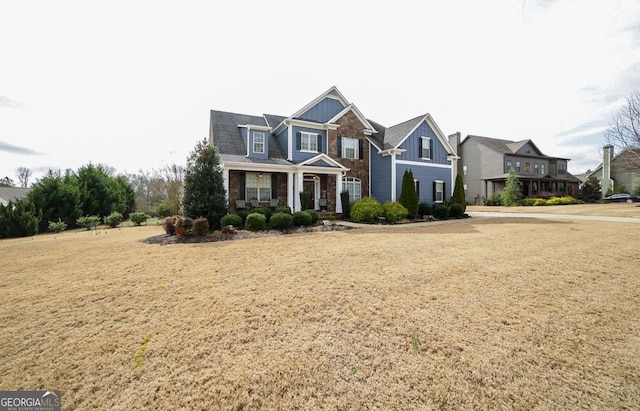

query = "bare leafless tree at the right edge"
[{"left": 605, "top": 90, "right": 640, "bottom": 170}]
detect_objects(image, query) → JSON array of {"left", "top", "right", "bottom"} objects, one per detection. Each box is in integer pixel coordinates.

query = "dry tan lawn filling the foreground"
[{"left": 0, "top": 210, "right": 640, "bottom": 410}]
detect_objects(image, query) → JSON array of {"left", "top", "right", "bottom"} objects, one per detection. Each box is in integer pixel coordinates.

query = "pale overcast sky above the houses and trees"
[{"left": 0, "top": 0, "right": 640, "bottom": 182}]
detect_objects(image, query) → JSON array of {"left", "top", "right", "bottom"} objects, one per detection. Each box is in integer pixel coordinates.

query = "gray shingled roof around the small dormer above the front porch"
[{"left": 209, "top": 110, "right": 285, "bottom": 161}]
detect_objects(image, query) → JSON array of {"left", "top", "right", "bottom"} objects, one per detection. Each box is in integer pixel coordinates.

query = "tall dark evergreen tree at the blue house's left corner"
[{"left": 182, "top": 140, "right": 228, "bottom": 229}]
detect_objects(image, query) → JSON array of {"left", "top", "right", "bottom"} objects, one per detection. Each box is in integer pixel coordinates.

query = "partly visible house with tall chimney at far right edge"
[{"left": 589, "top": 144, "right": 640, "bottom": 196}]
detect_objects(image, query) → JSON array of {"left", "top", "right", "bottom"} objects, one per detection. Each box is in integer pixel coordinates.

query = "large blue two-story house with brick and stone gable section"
[{"left": 209, "top": 87, "right": 458, "bottom": 213}]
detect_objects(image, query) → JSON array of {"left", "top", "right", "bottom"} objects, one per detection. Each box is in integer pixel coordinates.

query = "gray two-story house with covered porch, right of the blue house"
[{"left": 449, "top": 133, "right": 580, "bottom": 203}]
